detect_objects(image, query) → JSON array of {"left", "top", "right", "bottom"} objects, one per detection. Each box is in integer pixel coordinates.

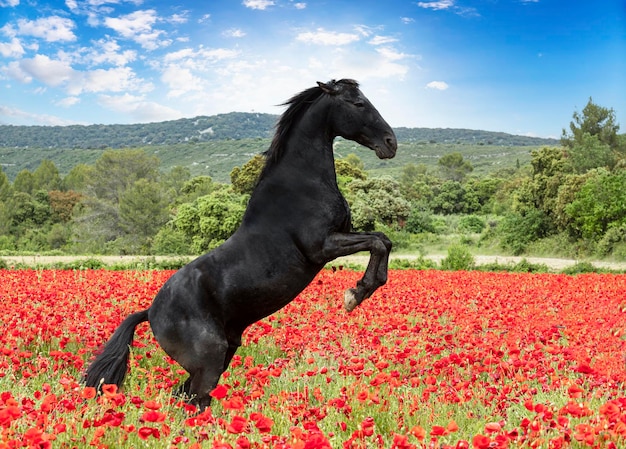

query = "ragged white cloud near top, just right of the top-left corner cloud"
[{"left": 104, "top": 9, "right": 171, "bottom": 50}]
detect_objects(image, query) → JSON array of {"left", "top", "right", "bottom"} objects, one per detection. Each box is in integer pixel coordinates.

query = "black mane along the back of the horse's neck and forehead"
[{"left": 265, "top": 79, "right": 359, "bottom": 165}]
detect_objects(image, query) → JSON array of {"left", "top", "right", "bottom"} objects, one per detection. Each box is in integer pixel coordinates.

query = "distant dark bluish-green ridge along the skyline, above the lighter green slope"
[{"left": 0, "top": 112, "right": 559, "bottom": 149}]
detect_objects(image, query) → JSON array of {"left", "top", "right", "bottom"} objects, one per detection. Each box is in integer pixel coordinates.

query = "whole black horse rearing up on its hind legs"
[{"left": 84, "top": 79, "right": 397, "bottom": 409}]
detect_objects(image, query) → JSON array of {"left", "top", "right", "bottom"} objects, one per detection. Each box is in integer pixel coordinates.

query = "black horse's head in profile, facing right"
[{"left": 317, "top": 79, "right": 398, "bottom": 159}]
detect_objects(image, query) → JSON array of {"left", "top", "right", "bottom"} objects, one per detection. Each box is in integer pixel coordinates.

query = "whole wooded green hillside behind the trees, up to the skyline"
[{"left": 0, "top": 112, "right": 559, "bottom": 182}]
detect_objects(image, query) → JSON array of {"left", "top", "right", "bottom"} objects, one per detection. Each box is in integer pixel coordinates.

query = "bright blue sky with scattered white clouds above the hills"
[{"left": 0, "top": 0, "right": 626, "bottom": 137}]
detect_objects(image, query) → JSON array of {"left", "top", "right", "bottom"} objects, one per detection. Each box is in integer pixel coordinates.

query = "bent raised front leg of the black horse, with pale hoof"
[{"left": 323, "top": 232, "right": 391, "bottom": 312}]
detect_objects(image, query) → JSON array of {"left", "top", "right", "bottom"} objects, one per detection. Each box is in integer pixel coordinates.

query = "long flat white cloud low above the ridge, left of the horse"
[{"left": 98, "top": 94, "right": 183, "bottom": 123}]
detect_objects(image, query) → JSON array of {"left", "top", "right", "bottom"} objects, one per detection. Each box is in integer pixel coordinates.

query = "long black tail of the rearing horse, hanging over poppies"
[{"left": 83, "top": 309, "right": 148, "bottom": 390}]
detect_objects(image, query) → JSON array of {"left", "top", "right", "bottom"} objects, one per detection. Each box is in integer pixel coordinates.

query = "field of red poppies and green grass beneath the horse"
[{"left": 0, "top": 269, "right": 626, "bottom": 449}]
